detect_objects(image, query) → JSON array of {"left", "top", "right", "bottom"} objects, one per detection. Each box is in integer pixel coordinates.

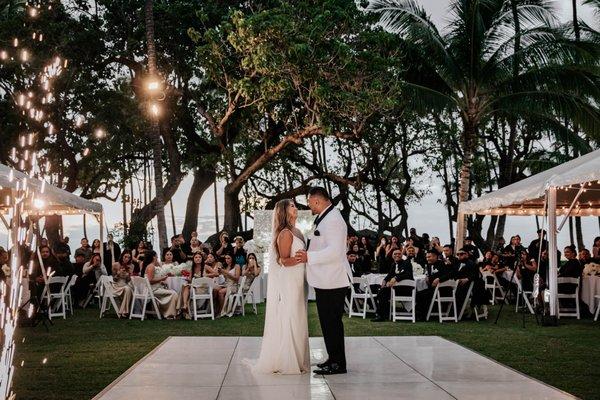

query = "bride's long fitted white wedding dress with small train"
[{"left": 253, "top": 236, "right": 310, "bottom": 374}]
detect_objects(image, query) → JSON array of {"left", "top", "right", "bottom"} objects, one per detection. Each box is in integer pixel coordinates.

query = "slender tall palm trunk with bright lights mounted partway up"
[{"left": 144, "top": 0, "right": 168, "bottom": 250}]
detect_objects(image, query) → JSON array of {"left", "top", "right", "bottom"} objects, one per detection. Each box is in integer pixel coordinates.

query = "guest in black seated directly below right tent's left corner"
[{"left": 452, "top": 248, "right": 489, "bottom": 313}]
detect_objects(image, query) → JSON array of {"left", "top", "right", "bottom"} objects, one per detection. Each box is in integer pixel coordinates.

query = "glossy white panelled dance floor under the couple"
[{"left": 95, "top": 336, "right": 574, "bottom": 400}]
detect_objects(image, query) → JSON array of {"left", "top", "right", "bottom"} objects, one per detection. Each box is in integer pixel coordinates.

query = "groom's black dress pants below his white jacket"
[{"left": 315, "top": 287, "right": 348, "bottom": 369}]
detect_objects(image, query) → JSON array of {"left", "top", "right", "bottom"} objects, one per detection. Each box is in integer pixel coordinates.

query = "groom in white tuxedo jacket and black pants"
[{"left": 296, "top": 187, "right": 350, "bottom": 375}]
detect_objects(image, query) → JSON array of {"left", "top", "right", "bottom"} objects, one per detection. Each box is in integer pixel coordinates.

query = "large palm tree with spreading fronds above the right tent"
[{"left": 367, "top": 0, "right": 600, "bottom": 243}]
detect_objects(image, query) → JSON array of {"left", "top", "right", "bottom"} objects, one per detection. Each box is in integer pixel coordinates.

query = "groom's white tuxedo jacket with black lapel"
[{"left": 306, "top": 207, "right": 352, "bottom": 289}]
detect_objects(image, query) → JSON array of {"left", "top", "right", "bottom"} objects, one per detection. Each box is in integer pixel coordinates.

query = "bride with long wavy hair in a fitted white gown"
[{"left": 254, "top": 199, "right": 310, "bottom": 374}]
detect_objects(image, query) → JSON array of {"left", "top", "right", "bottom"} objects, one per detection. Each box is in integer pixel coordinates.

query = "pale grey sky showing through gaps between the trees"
[{"left": 0, "top": 0, "right": 600, "bottom": 253}]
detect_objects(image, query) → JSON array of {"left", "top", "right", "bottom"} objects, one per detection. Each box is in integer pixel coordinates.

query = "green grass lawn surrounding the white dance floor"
[{"left": 14, "top": 303, "right": 600, "bottom": 400}]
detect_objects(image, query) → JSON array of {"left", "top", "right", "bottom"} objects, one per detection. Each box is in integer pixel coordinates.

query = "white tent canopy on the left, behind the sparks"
[{"left": 0, "top": 164, "right": 102, "bottom": 216}]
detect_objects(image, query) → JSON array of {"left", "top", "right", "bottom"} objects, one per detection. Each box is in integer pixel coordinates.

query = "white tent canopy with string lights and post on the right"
[{"left": 456, "top": 150, "right": 600, "bottom": 316}]
